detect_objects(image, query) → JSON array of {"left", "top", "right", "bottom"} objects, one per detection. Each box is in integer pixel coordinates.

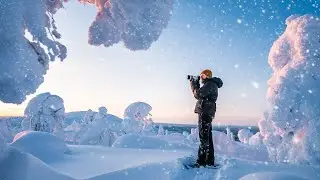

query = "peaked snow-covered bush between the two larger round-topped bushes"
[{"left": 75, "top": 107, "right": 123, "bottom": 146}]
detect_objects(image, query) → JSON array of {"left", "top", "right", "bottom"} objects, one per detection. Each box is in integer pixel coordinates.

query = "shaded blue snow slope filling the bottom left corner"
[{"left": 0, "top": 147, "right": 73, "bottom": 180}]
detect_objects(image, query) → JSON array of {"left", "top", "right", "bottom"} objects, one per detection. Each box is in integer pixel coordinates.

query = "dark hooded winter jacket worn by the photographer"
[{"left": 190, "top": 77, "right": 223, "bottom": 116}]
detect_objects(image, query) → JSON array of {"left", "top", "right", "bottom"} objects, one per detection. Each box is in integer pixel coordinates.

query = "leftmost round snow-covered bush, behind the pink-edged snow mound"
[{"left": 22, "top": 93, "right": 65, "bottom": 137}]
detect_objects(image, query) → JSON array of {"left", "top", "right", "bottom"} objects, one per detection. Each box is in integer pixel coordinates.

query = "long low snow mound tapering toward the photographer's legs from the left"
[{"left": 112, "top": 134, "right": 190, "bottom": 149}]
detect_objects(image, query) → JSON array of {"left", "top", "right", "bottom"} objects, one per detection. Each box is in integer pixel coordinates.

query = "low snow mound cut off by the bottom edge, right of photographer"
[{"left": 240, "top": 172, "right": 307, "bottom": 180}]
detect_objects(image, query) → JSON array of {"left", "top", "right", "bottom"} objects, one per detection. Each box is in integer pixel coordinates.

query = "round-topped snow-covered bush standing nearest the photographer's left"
[{"left": 122, "top": 102, "right": 154, "bottom": 133}]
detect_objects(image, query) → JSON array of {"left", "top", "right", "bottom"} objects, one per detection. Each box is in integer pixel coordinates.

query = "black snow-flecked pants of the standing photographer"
[{"left": 197, "top": 114, "right": 215, "bottom": 166}]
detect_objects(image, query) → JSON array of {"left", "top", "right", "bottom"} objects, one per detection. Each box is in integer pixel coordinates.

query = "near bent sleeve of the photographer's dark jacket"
[{"left": 193, "top": 83, "right": 218, "bottom": 99}]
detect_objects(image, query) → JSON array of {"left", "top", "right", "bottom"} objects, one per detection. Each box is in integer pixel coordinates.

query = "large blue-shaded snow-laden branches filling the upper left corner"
[{"left": 0, "top": 0, "right": 67, "bottom": 104}]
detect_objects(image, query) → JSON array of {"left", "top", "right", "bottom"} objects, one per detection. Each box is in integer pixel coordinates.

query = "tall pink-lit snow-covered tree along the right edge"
[{"left": 259, "top": 15, "right": 320, "bottom": 164}]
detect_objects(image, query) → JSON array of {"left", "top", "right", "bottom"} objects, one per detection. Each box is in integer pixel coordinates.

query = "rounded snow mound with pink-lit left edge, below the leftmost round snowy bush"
[{"left": 11, "top": 131, "right": 70, "bottom": 162}]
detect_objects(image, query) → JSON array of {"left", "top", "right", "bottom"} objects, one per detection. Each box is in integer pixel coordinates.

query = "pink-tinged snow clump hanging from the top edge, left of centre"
[{"left": 80, "top": 0, "right": 173, "bottom": 50}]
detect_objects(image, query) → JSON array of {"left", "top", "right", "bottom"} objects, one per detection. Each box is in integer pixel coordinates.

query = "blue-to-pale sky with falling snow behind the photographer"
[{"left": 0, "top": 0, "right": 319, "bottom": 124}]
